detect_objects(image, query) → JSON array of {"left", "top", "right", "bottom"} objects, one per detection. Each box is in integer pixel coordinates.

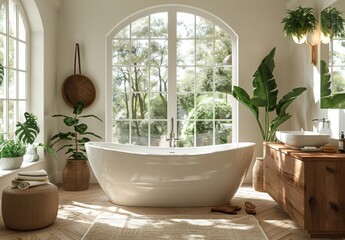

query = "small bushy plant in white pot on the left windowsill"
[{"left": 0, "top": 139, "right": 26, "bottom": 170}]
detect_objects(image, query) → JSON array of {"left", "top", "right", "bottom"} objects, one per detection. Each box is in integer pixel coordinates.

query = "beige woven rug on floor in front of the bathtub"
[{"left": 83, "top": 214, "right": 268, "bottom": 240}]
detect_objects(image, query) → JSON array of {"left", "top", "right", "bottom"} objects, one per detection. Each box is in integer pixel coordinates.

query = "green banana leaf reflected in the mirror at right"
[{"left": 320, "top": 60, "right": 345, "bottom": 108}]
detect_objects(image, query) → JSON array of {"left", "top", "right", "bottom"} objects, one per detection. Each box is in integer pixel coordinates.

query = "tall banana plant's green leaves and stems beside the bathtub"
[{"left": 232, "top": 48, "right": 306, "bottom": 141}]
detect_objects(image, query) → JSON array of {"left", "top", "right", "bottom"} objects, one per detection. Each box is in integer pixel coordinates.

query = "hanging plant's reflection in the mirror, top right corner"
[{"left": 321, "top": 7, "right": 345, "bottom": 39}]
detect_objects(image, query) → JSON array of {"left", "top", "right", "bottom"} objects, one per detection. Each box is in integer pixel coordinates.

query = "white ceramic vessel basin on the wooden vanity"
[{"left": 276, "top": 131, "right": 331, "bottom": 148}]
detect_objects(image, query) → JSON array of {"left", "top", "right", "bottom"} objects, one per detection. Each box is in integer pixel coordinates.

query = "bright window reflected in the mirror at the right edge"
[{"left": 329, "top": 38, "right": 345, "bottom": 93}]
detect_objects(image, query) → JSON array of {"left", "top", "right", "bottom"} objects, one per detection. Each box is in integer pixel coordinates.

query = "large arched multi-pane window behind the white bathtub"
[{"left": 107, "top": 6, "right": 236, "bottom": 147}]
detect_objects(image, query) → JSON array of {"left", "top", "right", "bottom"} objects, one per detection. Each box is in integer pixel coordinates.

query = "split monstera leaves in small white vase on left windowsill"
[{"left": 15, "top": 112, "right": 40, "bottom": 144}]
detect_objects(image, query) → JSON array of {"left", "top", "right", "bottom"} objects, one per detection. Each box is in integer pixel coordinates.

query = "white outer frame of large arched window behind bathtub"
[{"left": 105, "top": 4, "right": 238, "bottom": 142}]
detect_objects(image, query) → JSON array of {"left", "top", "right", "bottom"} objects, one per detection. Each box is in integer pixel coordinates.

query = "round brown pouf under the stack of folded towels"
[{"left": 1, "top": 183, "right": 59, "bottom": 230}]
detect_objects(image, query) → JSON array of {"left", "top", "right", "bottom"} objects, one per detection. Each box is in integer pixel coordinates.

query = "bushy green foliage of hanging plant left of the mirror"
[{"left": 282, "top": 6, "right": 317, "bottom": 40}]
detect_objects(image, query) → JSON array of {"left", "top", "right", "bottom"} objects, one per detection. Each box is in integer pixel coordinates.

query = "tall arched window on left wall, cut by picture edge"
[{"left": 0, "top": 0, "right": 28, "bottom": 137}]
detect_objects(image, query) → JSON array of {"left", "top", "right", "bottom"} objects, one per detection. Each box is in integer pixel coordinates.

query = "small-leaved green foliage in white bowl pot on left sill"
[{"left": 0, "top": 139, "right": 26, "bottom": 158}]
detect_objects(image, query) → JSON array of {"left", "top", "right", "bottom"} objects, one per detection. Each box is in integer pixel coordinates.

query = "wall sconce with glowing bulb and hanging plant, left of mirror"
[{"left": 282, "top": 6, "right": 317, "bottom": 65}]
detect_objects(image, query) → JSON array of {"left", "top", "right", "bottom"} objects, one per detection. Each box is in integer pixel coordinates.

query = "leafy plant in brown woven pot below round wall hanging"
[{"left": 50, "top": 101, "right": 103, "bottom": 191}]
